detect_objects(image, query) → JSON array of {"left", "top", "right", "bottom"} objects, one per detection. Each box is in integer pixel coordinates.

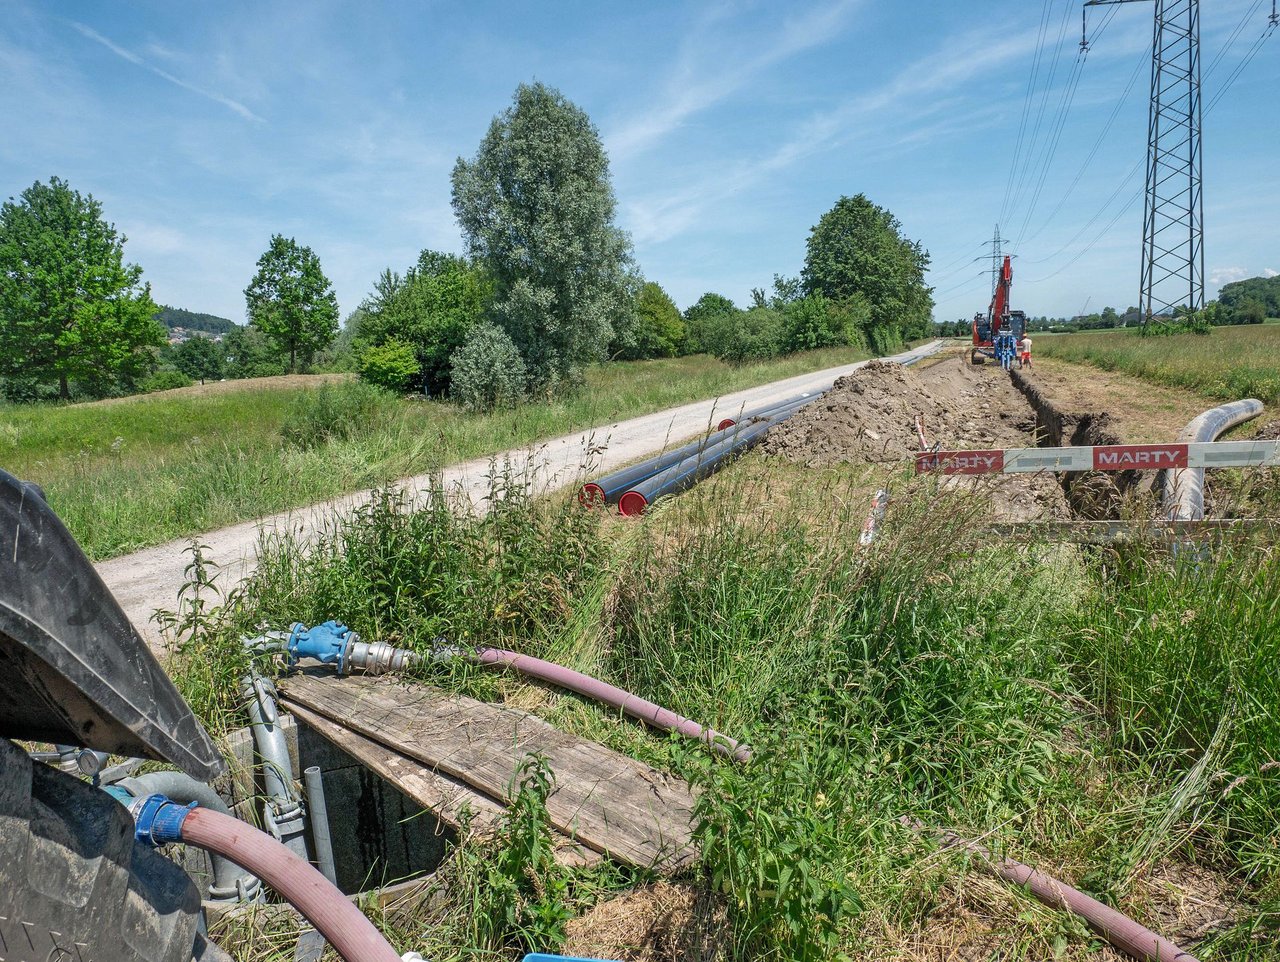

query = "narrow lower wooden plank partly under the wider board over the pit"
[{"left": 289, "top": 702, "right": 600, "bottom": 866}]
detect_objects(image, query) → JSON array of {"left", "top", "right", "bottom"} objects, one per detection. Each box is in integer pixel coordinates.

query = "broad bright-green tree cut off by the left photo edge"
[{"left": 0, "top": 177, "right": 165, "bottom": 398}]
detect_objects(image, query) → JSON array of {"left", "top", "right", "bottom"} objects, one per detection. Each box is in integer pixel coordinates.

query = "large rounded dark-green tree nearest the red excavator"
[{"left": 801, "top": 194, "right": 933, "bottom": 349}]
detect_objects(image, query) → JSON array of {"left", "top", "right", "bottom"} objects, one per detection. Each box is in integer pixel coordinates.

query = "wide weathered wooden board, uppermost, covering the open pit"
[{"left": 280, "top": 674, "right": 696, "bottom": 871}]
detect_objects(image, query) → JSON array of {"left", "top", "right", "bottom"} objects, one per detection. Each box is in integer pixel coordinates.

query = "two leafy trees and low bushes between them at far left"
[{"left": 0, "top": 177, "right": 338, "bottom": 399}]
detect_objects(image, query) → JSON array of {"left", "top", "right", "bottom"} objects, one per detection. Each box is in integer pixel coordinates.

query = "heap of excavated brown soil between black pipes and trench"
[{"left": 762, "top": 359, "right": 1033, "bottom": 467}]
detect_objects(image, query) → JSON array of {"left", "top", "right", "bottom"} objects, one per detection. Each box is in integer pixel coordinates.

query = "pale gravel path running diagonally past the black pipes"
[{"left": 96, "top": 342, "right": 943, "bottom": 646}]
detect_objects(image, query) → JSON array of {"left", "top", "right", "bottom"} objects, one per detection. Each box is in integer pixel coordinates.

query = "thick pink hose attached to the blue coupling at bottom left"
[{"left": 182, "top": 807, "right": 401, "bottom": 962}]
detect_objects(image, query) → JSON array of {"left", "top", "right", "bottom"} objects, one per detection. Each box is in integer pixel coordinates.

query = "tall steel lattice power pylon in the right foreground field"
[{"left": 1084, "top": 0, "right": 1204, "bottom": 326}]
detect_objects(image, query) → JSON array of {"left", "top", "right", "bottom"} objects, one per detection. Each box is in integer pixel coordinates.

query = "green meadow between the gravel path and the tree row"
[{"left": 0, "top": 349, "right": 880, "bottom": 559}]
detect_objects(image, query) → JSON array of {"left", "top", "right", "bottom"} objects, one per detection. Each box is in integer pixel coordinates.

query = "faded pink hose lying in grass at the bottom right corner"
[{"left": 902, "top": 819, "right": 1197, "bottom": 962}]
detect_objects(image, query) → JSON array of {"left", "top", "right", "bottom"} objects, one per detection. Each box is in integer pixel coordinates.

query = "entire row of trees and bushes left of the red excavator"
[{"left": 0, "top": 83, "right": 932, "bottom": 407}]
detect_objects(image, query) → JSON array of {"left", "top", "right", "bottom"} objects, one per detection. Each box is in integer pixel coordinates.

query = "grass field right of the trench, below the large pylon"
[{"left": 1036, "top": 325, "right": 1280, "bottom": 404}]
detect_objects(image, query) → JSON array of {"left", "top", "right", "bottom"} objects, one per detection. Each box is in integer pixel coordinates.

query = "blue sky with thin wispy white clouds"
[{"left": 0, "top": 0, "right": 1280, "bottom": 321}]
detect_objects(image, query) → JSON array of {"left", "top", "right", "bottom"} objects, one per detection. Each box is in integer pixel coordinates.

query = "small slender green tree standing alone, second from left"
[{"left": 244, "top": 234, "right": 338, "bottom": 372}]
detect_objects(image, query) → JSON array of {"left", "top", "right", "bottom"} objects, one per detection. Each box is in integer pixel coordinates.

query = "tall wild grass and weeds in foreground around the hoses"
[{"left": 167, "top": 457, "right": 1280, "bottom": 962}]
